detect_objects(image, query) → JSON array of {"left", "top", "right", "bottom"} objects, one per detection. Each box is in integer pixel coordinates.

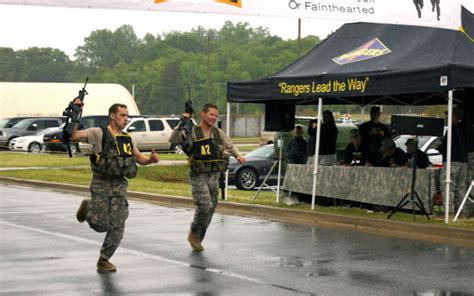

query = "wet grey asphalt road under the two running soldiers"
[{"left": 0, "top": 184, "right": 474, "bottom": 295}]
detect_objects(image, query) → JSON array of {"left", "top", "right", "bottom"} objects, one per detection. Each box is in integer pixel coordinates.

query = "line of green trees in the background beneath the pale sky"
[{"left": 0, "top": 22, "right": 320, "bottom": 114}]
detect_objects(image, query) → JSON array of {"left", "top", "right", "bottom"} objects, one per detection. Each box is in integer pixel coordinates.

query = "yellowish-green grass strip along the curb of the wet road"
[{"left": 0, "top": 166, "right": 474, "bottom": 229}]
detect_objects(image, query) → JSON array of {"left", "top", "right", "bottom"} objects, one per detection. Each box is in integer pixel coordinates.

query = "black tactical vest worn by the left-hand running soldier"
[{"left": 90, "top": 127, "right": 138, "bottom": 179}]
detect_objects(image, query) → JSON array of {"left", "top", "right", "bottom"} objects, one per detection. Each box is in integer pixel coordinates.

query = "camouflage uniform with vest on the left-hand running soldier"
[{"left": 81, "top": 128, "right": 137, "bottom": 260}]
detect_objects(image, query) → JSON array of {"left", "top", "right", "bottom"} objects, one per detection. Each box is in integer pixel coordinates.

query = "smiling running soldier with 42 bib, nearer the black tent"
[{"left": 169, "top": 103, "right": 245, "bottom": 252}]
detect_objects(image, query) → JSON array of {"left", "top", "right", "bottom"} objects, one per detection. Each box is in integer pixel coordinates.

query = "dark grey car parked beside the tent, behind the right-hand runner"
[{"left": 229, "top": 144, "right": 278, "bottom": 190}]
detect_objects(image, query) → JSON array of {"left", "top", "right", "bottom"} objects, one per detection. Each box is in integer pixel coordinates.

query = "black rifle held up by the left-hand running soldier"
[{"left": 61, "top": 77, "right": 89, "bottom": 157}]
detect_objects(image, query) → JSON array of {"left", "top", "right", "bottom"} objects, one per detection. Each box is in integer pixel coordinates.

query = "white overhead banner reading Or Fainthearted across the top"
[{"left": 0, "top": 0, "right": 461, "bottom": 30}]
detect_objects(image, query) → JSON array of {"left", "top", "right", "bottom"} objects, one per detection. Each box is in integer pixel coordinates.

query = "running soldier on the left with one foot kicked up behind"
[{"left": 71, "top": 104, "right": 159, "bottom": 272}]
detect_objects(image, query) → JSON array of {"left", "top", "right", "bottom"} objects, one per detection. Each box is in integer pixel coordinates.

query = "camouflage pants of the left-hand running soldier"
[{"left": 86, "top": 176, "right": 128, "bottom": 259}]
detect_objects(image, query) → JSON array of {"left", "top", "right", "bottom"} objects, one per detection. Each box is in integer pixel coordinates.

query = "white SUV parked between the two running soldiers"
[{"left": 124, "top": 117, "right": 179, "bottom": 151}]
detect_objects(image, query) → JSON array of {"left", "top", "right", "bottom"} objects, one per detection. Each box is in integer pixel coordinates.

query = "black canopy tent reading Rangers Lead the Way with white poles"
[{"left": 227, "top": 8, "right": 474, "bottom": 223}]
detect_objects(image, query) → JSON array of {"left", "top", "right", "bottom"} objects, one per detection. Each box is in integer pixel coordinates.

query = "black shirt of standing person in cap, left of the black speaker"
[{"left": 359, "top": 121, "right": 390, "bottom": 163}]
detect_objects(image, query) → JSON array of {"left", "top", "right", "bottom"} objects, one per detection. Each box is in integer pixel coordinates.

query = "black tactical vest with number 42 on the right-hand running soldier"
[{"left": 189, "top": 127, "right": 229, "bottom": 173}]
